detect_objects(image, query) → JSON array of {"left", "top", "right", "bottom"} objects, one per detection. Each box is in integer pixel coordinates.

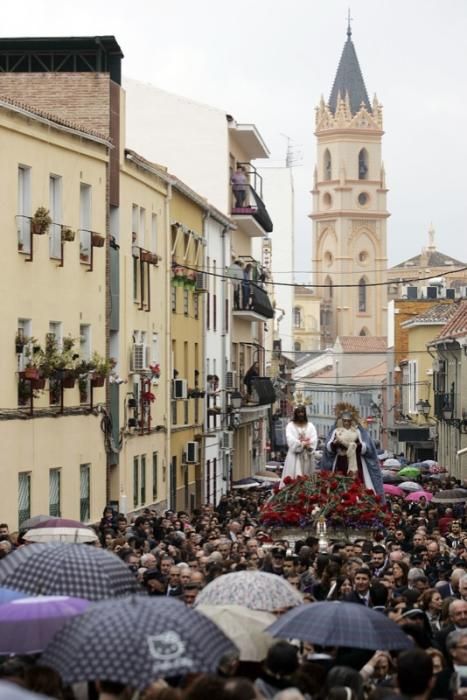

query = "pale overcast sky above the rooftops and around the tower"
[{"left": 0, "top": 0, "right": 467, "bottom": 270}]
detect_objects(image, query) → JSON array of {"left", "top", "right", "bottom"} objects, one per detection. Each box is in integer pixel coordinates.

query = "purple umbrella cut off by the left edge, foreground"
[{"left": 0, "top": 596, "right": 91, "bottom": 655}]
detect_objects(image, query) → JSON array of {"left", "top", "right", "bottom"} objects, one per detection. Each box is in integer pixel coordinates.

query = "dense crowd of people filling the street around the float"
[{"left": 0, "top": 462, "right": 467, "bottom": 700}]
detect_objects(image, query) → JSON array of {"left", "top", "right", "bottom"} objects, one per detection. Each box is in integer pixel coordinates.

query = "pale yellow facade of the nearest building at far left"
[{"left": 0, "top": 100, "right": 110, "bottom": 528}]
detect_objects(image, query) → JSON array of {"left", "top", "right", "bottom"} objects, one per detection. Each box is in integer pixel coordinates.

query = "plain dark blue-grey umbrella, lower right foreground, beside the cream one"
[{"left": 266, "top": 602, "right": 412, "bottom": 651}]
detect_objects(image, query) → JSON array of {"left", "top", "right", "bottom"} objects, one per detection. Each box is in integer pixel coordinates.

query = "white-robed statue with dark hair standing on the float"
[{"left": 279, "top": 405, "right": 318, "bottom": 488}]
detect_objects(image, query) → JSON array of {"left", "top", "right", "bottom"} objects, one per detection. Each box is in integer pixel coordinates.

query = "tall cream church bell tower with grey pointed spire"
[{"left": 311, "top": 21, "right": 389, "bottom": 347}]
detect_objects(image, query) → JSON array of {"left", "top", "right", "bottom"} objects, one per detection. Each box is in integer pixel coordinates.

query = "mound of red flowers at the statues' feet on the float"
[{"left": 260, "top": 471, "right": 391, "bottom": 530}]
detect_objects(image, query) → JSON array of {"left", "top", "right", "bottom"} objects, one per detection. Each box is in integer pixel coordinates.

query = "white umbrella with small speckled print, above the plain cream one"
[{"left": 195, "top": 571, "right": 303, "bottom": 612}]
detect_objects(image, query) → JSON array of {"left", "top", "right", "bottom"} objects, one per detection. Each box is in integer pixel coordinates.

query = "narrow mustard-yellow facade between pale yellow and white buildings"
[{"left": 169, "top": 185, "right": 207, "bottom": 510}]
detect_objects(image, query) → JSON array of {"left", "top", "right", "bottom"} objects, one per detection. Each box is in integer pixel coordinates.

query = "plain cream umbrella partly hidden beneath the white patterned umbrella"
[{"left": 196, "top": 605, "right": 276, "bottom": 661}]
